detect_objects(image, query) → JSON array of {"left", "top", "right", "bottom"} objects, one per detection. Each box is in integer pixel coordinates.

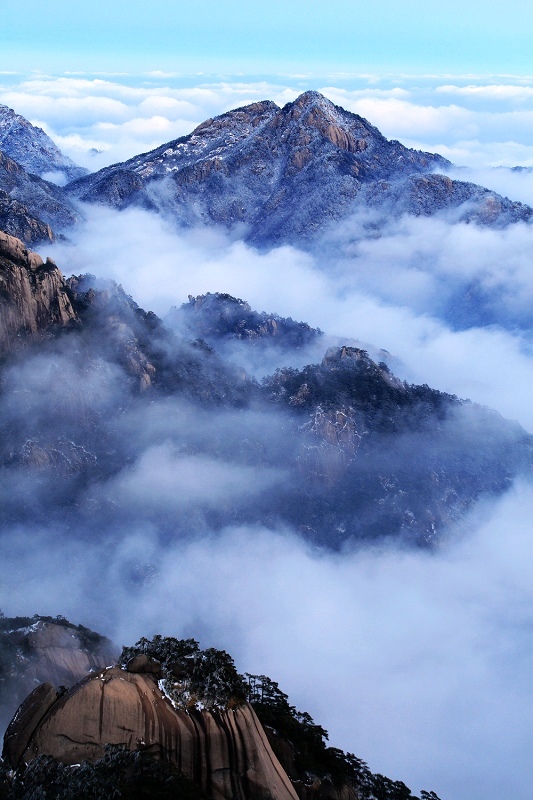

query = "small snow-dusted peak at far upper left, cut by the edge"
[{"left": 0, "top": 104, "right": 87, "bottom": 180}]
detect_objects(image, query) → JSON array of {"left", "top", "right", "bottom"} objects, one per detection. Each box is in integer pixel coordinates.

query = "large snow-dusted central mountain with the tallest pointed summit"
[{"left": 67, "top": 92, "right": 533, "bottom": 246}]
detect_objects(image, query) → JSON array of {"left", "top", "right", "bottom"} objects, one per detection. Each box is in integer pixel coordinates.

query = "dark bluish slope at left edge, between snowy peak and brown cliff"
[{"left": 0, "top": 150, "right": 82, "bottom": 239}]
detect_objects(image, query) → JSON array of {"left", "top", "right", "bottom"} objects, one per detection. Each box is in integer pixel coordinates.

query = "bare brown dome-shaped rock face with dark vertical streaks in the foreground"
[{"left": 4, "top": 667, "right": 297, "bottom": 800}]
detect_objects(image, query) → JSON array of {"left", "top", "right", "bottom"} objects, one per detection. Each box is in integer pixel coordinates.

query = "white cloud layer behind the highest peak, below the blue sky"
[{"left": 0, "top": 71, "right": 533, "bottom": 169}]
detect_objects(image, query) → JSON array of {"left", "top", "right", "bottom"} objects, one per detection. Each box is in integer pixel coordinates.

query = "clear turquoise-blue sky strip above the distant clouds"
[{"left": 1, "top": 0, "right": 533, "bottom": 74}]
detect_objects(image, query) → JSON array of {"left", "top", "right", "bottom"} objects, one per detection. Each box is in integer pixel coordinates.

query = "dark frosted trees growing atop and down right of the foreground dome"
[{"left": 120, "top": 636, "right": 438, "bottom": 800}]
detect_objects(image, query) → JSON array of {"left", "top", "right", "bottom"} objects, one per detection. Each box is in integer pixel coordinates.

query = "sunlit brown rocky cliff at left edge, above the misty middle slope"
[{"left": 0, "top": 231, "right": 76, "bottom": 353}]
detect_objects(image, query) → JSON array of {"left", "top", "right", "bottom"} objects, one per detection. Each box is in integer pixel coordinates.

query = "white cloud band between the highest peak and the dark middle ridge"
[{"left": 43, "top": 207, "right": 533, "bottom": 430}]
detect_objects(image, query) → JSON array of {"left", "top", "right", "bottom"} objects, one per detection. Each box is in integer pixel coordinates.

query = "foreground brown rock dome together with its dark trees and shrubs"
[{"left": 0, "top": 632, "right": 438, "bottom": 800}]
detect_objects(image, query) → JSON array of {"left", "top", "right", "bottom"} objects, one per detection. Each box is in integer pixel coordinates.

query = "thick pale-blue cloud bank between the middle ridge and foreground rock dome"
[{"left": 0, "top": 486, "right": 533, "bottom": 800}]
